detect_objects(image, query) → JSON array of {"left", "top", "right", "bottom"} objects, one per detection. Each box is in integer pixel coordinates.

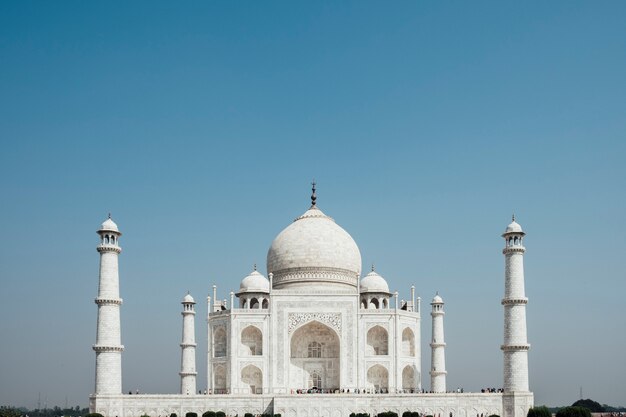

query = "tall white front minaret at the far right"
[{"left": 501, "top": 216, "right": 530, "bottom": 393}]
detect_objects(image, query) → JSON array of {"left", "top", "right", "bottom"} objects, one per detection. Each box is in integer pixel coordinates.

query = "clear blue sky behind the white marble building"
[{"left": 0, "top": 1, "right": 626, "bottom": 407}]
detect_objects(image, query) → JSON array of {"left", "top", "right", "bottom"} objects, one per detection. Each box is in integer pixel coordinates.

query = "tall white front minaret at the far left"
[{"left": 93, "top": 214, "right": 124, "bottom": 394}]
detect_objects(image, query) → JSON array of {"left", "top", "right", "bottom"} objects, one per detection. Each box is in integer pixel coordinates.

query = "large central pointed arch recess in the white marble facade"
[{"left": 289, "top": 321, "right": 341, "bottom": 390}]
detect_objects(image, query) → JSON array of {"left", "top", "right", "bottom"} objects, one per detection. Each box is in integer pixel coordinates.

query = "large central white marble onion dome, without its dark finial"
[{"left": 267, "top": 204, "right": 361, "bottom": 288}]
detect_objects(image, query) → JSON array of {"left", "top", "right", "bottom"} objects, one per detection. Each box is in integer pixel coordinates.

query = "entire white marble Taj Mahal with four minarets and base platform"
[{"left": 89, "top": 184, "right": 533, "bottom": 417}]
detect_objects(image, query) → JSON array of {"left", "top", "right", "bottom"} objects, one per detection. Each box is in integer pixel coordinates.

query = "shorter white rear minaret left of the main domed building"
[{"left": 179, "top": 294, "right": 198, "bottom": 395}]
